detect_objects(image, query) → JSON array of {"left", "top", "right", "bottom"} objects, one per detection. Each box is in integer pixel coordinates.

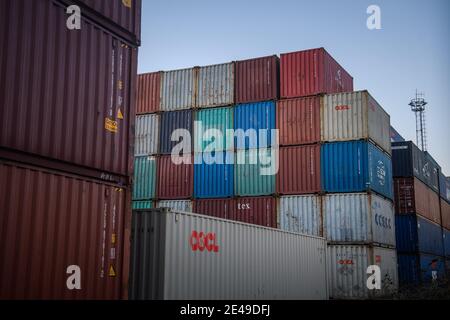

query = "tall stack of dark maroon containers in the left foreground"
[{"left": 0, "top": 0, "right": 141, "bottom": 299}]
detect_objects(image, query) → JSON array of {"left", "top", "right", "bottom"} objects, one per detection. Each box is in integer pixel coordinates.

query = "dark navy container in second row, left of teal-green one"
[{"left": 159, "top": 110, "right": 194, "bottom": 154}]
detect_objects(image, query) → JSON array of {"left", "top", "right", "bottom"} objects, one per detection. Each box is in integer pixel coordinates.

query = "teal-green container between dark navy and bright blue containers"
[{"left": 194, "top": 107, "right": 234, "bottom": 152}]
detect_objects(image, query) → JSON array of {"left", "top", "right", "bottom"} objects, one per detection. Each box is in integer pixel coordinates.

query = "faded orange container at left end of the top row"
[{"left": 136, "top": 72, "right": 161, "bottom": 114}]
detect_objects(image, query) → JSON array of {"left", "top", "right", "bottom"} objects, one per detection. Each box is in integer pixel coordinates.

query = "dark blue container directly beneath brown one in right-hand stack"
[{"left": 395, "top": 214, "right": 444, "bottom": 256}]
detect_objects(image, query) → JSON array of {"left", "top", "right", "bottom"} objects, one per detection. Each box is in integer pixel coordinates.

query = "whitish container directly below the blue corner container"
[{"left": 322, "top": 193, "right": 395, "bottom": 247}]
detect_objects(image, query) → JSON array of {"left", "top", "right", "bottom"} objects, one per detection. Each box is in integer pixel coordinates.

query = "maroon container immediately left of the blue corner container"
[{"left": 277, "top": 145, "right": 320, "bottom": 194}]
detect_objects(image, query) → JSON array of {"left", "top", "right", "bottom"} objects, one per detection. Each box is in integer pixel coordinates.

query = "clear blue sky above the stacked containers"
[{"left": 139, "top": 0, "right": 450, "bottom": 175}]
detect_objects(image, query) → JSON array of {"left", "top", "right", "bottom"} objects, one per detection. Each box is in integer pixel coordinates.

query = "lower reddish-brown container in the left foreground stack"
[{"left": 0, "top": 161, "right": 131, "bottom": 300}]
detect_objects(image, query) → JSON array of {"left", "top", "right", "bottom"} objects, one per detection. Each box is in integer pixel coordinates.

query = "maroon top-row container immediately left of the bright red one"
[{"left": 235, "top": 56, "right": 279, "bottom": 103}]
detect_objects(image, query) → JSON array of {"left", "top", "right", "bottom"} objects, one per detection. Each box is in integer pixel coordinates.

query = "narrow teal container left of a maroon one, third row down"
[{"left": 133, "top": 156, "right": 156, "bottom": 200}]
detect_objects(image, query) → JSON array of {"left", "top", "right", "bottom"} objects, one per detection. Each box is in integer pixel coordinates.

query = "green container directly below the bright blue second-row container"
[{"left": 234, "top": 149, "right": 277, "bottom": 196}]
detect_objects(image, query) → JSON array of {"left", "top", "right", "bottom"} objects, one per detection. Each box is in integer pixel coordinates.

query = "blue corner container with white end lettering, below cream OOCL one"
[{"left": 320, "top": 141, "right": 393, "bottom": 199}]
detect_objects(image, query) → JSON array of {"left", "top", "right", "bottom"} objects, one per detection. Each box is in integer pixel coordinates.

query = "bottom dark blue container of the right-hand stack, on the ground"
[{"left": 398, "top": 253, "right": 445, "bottom": 286}]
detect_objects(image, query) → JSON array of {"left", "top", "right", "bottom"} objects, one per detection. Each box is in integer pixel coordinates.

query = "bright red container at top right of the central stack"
[{"left": 280, "top": 48, "right": 353, "bottom": 98}]
